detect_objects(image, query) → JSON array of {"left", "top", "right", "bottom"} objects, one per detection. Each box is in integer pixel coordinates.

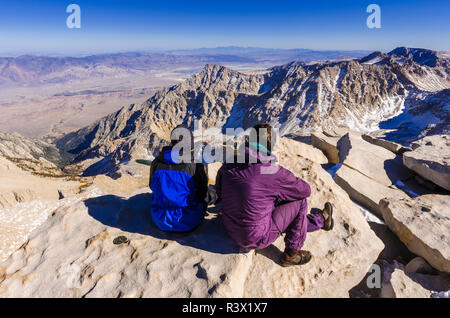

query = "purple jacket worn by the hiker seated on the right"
[{"left": 216, "top": 148, "right": 311, "bottom": 248}]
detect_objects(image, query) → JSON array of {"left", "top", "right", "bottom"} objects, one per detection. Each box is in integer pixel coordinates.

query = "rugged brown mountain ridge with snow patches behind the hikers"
[{"left": 57, "top": 48, "right": 450, "bottom": 176}]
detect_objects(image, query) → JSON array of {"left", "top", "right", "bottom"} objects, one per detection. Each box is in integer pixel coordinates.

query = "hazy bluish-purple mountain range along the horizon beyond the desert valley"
[{"left": 0, "top": 47, "right": 367, "bottom": 87}]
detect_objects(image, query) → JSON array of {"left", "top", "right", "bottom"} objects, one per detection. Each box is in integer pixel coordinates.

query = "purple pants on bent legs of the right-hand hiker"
[{"left": 264, "top": 199, "right": 324, "bottom": 251}]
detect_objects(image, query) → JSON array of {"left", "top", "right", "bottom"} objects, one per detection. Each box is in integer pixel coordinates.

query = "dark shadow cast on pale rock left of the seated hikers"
[{"left": 84, "top": 193, "right": 241, "bottom": 254}]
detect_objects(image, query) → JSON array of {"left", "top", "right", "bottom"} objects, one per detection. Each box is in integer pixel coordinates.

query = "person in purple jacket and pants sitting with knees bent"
[{"left": 216, "top": 124, "right": 333, "bottom": 266}]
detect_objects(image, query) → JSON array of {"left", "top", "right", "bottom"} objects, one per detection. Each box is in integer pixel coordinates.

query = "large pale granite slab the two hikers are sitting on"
[{"left": 0, "top": 140, "right": 384, "bottom": 297}]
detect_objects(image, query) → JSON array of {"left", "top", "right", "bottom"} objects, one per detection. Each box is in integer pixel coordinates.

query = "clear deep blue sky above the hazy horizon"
[{"left": 0, "top": 0, "right": 450, "bottom": 55}]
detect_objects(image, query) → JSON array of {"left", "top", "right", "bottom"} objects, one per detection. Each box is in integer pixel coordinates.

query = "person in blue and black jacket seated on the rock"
[{"left": 150, "top": 126, "right": 216, "bottom": 232}]
